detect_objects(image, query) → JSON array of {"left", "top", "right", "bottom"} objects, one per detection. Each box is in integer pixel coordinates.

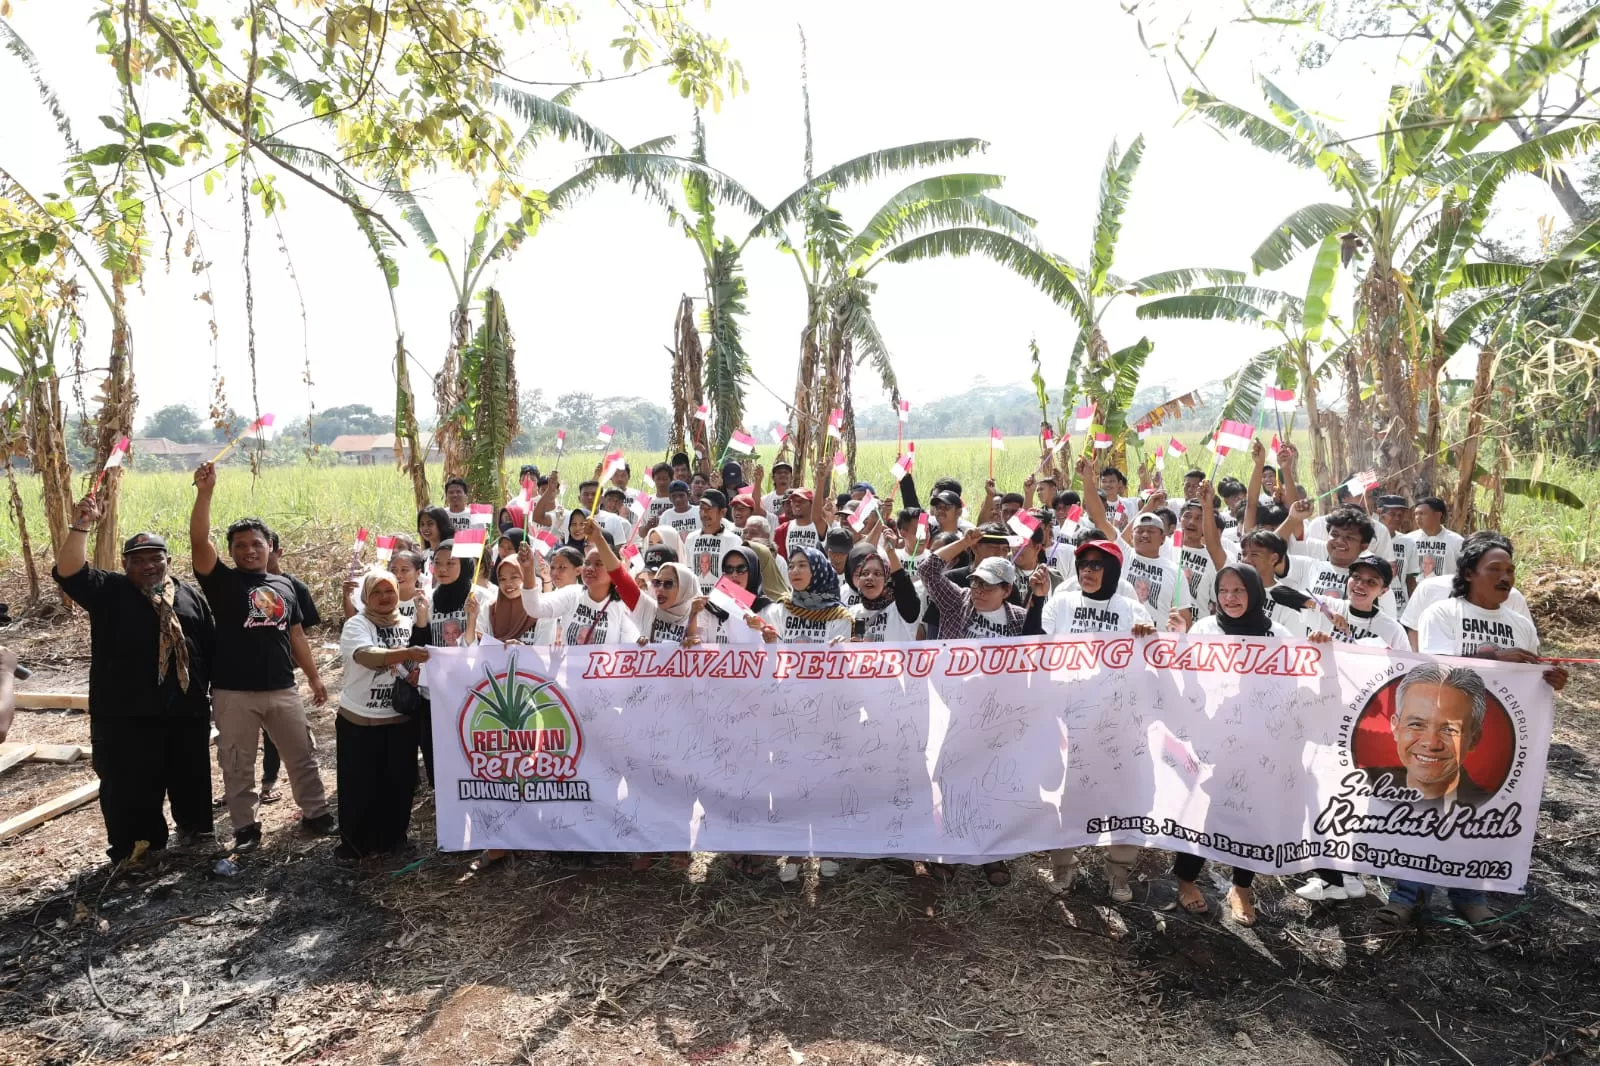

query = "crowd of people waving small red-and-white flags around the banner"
[{"left": 31, "top": 442, "right": 1566, "bottom": 925}]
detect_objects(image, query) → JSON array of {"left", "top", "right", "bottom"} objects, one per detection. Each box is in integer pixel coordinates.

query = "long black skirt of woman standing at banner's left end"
[{"left": 333, "top": 715, "right": 416, "bottom": 855}]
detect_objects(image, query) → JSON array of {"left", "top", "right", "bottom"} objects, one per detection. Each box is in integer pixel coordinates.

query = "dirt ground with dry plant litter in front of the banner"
[{"left": 0, "top": 575, "right": 1600, "bottom": 1066}]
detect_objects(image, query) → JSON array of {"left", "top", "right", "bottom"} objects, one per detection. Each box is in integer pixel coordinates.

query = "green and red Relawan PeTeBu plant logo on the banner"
[{"left": 458, "top": 651, "right": 589, "bottom": 804}]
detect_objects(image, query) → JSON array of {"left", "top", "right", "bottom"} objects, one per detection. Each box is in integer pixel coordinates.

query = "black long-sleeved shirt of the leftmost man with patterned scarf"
[{"left": 50, "top": 567, "right": 216, "bottom": 719}]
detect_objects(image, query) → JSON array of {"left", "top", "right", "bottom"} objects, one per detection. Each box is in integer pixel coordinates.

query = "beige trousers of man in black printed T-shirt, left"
[{"left": 211, "top": 688, "right": 328, "bottom": 829}]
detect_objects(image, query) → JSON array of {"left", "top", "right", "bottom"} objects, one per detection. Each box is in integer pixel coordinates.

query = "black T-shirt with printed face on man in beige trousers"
[{"left": 195, "top": 560, "right": 301, "bottom": 691}]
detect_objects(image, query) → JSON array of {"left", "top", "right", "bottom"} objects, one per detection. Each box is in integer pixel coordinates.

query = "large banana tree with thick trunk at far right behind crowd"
[{"left": 1186, "top": 3, "right": 1600, "bottom": 487}]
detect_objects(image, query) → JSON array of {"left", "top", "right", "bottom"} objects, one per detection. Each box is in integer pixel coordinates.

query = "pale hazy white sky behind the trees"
[{"left": 0, "top": 0, "right": 1554, "bottom": 432}]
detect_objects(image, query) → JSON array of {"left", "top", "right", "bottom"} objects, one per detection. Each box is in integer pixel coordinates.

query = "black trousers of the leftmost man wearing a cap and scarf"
[{"left": 90, "top": 714, "right": 211, "bottom": 863}]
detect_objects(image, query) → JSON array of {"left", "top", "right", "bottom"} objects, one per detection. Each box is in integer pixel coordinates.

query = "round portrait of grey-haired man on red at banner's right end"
[{"left": 1350, "top": 663, "right": 1517, "bottom": 807}]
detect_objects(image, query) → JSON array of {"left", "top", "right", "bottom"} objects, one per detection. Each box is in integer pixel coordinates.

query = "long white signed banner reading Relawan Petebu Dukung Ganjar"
[{"left": 426, "top": 635, "right": 1552, "bottom": 892}]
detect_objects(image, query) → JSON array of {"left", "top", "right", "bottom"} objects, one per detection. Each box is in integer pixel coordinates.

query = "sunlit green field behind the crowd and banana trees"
[{"left": 0, "top": 434, "right": 1600, "bottom": 562}]
